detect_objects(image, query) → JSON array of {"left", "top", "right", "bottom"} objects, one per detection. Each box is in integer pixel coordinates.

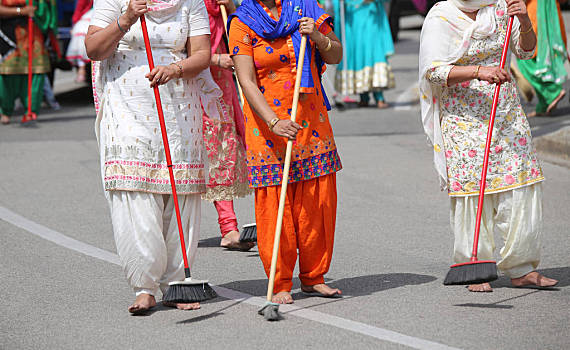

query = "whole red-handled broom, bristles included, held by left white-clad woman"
[{"left": 140, "top": 15, "right": 217, "bottom": 303}]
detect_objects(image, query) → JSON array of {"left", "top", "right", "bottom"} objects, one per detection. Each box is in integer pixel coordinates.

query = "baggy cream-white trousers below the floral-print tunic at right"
[{"left": 450, "top": 183, "right": 542, "bottom": 278}]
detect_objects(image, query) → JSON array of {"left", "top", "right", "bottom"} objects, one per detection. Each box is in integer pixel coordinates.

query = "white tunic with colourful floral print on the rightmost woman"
[{"left": 427, "top": 1, "right": 544, "bottom": 196}]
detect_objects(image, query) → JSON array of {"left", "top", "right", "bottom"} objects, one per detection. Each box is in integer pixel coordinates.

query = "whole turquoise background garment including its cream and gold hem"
[{"left": 333, "top": 0, "right": 394, "bottom": 95}]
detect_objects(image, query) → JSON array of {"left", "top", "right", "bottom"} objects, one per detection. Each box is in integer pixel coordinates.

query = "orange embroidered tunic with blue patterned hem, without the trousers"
[{"left": 229, "top": 0, "right": 342, "bottom": 188}]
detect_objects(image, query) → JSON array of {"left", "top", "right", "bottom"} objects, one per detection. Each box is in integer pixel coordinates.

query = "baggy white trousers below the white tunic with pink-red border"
[{"left": 107, "top": 191, "right": 201, "bottom": 296}]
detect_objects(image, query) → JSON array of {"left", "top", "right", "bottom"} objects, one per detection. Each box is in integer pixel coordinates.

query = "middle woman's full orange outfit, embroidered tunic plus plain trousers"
[{"left": 229, "top": 0, "right": 342, "bottom": 293}]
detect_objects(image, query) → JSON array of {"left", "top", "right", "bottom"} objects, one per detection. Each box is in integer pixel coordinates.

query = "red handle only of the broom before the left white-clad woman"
[{"left": 140, "top": 15, "right": 190, "bottom": 278}]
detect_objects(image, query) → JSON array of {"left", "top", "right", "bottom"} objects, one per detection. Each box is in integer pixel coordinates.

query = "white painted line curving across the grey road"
[{"left": 0, "top": 206, "right": 458, "bottom": 350}]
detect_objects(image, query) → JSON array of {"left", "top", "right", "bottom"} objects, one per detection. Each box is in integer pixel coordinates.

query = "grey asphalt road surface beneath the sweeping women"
[{"left": 0, "top": 17, "right": 570, "bottom": 349}]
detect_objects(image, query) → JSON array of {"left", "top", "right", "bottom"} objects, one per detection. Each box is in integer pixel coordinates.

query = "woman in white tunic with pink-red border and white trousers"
[{"left": 85, "top": 0, "right": 211, "bottom": 313}]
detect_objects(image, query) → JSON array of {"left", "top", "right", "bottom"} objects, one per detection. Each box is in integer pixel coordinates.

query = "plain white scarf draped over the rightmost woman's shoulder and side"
[{"left": 419, "top": 0, "right": 497, "bottom": 190}]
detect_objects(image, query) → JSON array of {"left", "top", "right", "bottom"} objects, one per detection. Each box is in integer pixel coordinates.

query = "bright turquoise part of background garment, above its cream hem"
[{"left": 333, "top": 0, "right": 394, "bottom": 72}]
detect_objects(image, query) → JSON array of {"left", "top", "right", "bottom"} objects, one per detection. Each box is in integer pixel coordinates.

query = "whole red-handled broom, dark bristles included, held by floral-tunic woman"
[{"left": 443, "top": 16, "right": 513, "bottom": 286}]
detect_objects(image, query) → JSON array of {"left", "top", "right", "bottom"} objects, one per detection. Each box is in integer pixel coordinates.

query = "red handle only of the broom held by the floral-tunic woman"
[{"left": 471, "top": 16, "right": 514, "bottom": 261}]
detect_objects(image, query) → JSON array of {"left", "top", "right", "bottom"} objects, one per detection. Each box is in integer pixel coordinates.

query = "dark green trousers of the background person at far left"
[{"left": 0, "top": 74, "right": 45, "bottom": 116}]
